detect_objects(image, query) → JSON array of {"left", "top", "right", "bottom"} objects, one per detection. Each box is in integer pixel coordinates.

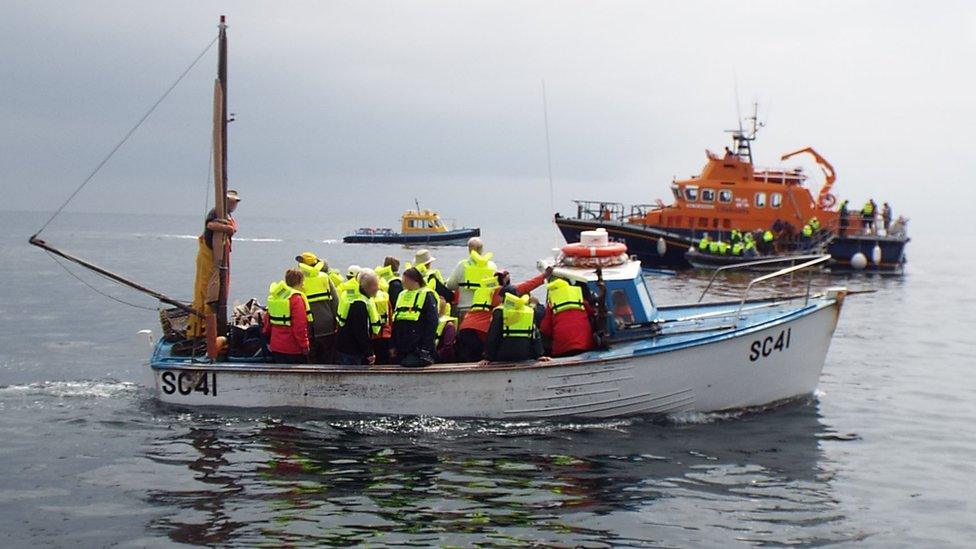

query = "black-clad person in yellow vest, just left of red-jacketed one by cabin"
[{"left": 478, "top": 294, "right": 549, "bottom": 366}]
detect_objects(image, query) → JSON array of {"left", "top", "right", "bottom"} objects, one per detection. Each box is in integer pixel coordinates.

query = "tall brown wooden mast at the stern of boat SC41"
[{"left": 213, "top": 15, "right": 230, "bottom": 334}]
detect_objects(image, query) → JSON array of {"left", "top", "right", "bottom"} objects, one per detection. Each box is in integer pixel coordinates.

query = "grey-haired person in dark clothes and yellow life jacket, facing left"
[{"left": 336, "top": 269, "right": 382, "bottom": 365}]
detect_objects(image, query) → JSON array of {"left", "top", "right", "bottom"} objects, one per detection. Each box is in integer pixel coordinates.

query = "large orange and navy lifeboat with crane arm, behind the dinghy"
[{"left": 555, "top": 103, "right": 909, "bottom": 271}]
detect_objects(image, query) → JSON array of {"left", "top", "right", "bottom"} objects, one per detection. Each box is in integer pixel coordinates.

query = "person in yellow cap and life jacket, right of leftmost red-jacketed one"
[{"left": 295, "top": 252, "right": 339, "bottom": 364}]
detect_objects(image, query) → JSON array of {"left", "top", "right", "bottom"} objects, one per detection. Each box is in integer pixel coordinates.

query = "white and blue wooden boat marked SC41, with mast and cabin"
[{"left": 24, "top": 18, "right": 847, "bottom": 418}]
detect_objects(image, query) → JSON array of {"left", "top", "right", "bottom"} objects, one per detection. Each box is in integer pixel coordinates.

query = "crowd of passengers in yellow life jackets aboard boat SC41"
[{"left": 263, "top": 234, "right": 596, "bottom": 367}]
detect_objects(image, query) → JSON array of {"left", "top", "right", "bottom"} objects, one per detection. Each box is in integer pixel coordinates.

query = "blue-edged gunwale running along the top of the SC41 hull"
[{"left": 149, "top": 297, "right": 839, "bottom": 377}]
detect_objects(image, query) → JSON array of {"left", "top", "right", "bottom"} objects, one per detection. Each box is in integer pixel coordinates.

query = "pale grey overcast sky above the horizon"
[{"left": 0, "top": 0, "right": 976, "bottom": 228}]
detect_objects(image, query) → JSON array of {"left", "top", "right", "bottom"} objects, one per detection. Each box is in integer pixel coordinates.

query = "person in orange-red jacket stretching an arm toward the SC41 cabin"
[{"left": 455, "top": 267, "right": 552, "bottom": 362}]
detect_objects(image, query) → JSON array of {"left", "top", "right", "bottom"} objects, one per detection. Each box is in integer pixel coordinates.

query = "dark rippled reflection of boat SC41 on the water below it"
[{"left": 146, "top": 401, "right": 845, "bottom": 546}]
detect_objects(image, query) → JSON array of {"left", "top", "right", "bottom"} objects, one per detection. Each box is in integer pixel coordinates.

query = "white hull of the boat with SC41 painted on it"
[{"left": 153, "top": 299, "right": 840, "bottom": 418}]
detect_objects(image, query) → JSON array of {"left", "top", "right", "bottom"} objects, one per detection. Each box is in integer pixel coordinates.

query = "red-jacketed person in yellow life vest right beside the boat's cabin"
[{"left": 540, "top": 278, "right": 596, "bottom": 356}]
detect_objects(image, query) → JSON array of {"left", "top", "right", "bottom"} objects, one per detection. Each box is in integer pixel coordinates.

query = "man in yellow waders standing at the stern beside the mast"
[{"left": 186, "top": 190, "right": 241, "bottom": 338}]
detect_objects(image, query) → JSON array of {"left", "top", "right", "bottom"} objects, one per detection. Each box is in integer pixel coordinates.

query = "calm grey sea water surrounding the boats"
[{"left": 0, "top": 212, "right": 976, "bottom": 547}]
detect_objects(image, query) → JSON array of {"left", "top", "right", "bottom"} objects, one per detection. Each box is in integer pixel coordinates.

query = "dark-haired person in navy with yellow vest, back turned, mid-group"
[{"left": 392, "top": 268, "right": 439, "bottom": 367}]
